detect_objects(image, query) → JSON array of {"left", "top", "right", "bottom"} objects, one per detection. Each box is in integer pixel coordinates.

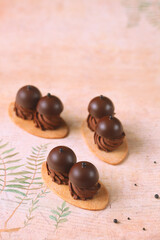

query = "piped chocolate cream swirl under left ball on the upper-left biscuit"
[{"left": 14, "top": 103, "right": 35, "bottom": 120}]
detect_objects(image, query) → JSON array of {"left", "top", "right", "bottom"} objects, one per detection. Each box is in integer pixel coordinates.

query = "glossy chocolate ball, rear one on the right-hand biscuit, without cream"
[{"left": 88, "top": 95, "right": 114, "bottom": 119}]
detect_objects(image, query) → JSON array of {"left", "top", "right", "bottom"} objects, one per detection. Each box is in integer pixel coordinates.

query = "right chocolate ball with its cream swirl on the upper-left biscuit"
[{"left": 34, "top": 93, "right": 63, "bottom": 130}]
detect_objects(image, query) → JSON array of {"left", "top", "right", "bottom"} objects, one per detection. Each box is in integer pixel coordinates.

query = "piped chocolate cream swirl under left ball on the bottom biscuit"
[{"left": 46, "top": 163, "right": 68, "bottom": 185}]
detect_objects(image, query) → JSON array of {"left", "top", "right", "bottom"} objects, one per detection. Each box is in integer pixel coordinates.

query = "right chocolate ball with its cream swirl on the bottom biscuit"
[{"left": 69, "top": 162, "right": 101, "bottom": 200}]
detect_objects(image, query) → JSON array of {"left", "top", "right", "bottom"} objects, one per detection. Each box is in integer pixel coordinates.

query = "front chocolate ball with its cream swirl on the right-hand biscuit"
[{"left": 94, "top": 116, "right": 125, "bottom": 152}]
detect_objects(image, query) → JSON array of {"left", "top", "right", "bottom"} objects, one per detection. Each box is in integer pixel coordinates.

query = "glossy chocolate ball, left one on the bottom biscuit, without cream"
[{"left": 47, "top": 146, "right": 77, "bottom": 173}]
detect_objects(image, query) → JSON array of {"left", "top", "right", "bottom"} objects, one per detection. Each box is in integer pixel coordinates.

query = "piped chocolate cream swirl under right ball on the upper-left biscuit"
[{"left": 34, "top": 112, "right": 63, "bottom": 131}]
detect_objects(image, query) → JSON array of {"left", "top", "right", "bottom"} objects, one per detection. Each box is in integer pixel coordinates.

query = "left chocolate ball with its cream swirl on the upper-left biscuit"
[{"left": 14, "top": 85, "right": 42, "bottom": 120}]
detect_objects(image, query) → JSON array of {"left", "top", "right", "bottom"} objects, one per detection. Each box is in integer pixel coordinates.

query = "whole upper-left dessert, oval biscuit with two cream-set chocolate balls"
[{"left": 8, "top": 88, "right": 69, "bottom": 139}]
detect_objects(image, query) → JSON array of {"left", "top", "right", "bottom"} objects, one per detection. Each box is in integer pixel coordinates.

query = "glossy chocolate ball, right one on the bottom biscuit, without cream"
[{"left": 69, "top": 162, "right": 99, "bottom": 188}]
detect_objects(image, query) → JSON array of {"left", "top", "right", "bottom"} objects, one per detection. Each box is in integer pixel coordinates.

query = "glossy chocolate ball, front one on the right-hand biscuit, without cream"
[{"left": 95, "top": 116, "right": 123, "bottom": 139}]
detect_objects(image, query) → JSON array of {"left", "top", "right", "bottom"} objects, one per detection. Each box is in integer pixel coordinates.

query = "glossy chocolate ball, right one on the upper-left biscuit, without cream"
[{"left": 37, "top": 93, "right": 63, "bottom": 116}]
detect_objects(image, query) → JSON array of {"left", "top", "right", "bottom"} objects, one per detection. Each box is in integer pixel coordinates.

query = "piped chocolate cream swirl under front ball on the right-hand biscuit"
[{"left": 94, "top": 132, "right": 125, "bottom": 152}]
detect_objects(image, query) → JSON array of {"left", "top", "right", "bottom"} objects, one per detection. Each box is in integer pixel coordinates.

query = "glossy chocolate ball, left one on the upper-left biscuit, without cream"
[{"left": 16, "top": 85, "right": 42, "bottom": 110}]
